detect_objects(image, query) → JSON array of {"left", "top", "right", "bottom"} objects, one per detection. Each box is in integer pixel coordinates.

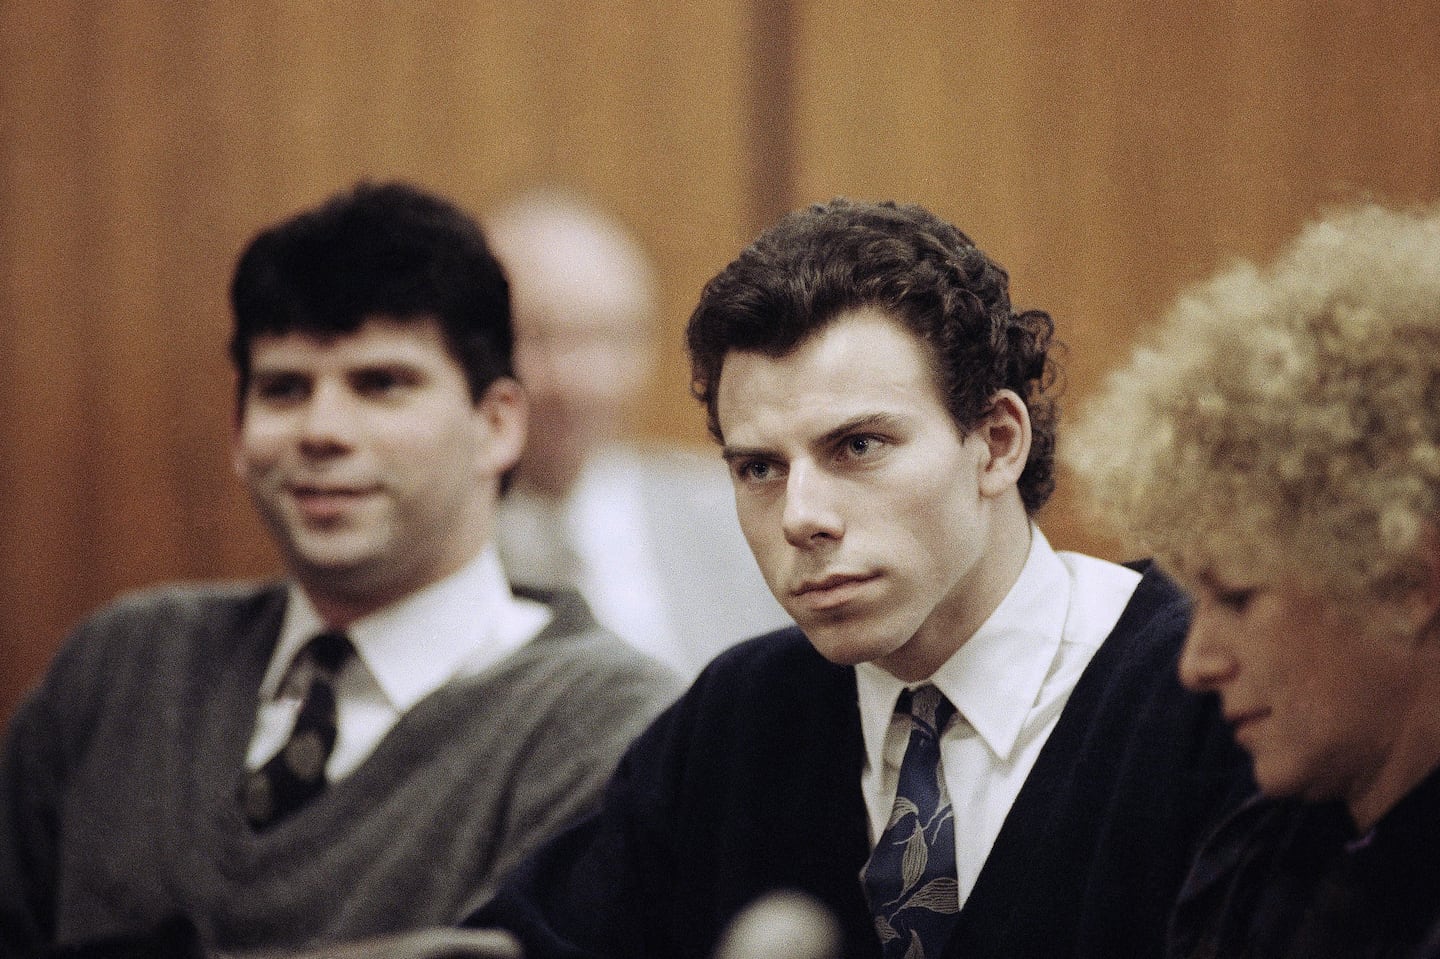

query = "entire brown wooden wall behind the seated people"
[{"left": 0, "top": 0, "right": 1440, "bottom": 717}]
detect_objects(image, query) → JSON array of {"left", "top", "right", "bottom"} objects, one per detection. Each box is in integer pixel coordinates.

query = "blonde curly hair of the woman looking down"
[{"left": 1063, "top": 204, "right": 1440, "bottom": 599}]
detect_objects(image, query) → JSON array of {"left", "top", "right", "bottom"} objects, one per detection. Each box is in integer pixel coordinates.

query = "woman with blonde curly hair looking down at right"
[{"left": 1073, "top": 206, "right": 1440, "bottom": 959}]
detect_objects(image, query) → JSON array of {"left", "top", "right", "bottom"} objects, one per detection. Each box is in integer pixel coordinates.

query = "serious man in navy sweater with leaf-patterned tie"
[{"left": 468, "top": 200, "right": 1248, "bottom": 959}]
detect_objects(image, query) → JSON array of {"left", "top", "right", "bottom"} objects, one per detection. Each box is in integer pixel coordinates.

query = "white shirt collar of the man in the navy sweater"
[{"left": 855, "top": 526, "right": 1071, "bottom": 765}]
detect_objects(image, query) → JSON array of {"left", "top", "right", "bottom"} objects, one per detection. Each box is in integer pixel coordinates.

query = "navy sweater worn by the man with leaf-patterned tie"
[{"left": 467, "top": 569, "right": 1250, "bottom": 959}]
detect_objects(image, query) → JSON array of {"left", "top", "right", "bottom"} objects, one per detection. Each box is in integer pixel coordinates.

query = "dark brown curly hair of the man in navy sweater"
[{"left": 685, "top": 197, "right": 1058, "bottom": 514}]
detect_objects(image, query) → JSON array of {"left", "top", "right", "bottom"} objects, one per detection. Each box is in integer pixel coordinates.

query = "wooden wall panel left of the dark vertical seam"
[{"left": 0, "top": 0, "right": 750, "bottom": 716}]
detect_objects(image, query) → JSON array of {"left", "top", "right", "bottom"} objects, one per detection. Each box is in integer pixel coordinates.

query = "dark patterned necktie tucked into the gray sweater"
[{"left": 240, "top": 632, "right": 354, "bottom": 829}]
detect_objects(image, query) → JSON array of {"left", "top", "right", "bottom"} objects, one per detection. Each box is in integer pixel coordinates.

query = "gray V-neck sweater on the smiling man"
[{"left": 0, "top": 585, "right": 678, "bottom": 956}]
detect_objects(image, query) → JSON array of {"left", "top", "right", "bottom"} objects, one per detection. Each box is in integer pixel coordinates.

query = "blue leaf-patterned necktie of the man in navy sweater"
[{"left": 860, "top": 684, "right": 960, "bottom": 959}]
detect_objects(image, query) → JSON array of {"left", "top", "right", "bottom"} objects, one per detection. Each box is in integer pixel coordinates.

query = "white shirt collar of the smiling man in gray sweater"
[{"left": 261, "top": 546, "right": 550, "bottom": 713}]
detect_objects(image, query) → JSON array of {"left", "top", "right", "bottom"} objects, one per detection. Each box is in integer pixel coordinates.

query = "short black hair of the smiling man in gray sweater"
[{"left": 230, "top": 181, "right": 514, "bottom": 406}]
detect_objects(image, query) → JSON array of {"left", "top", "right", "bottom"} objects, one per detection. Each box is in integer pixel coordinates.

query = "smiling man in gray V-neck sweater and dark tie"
[{"left": 0, "top": 184, "right": 675, "bottom": 956}]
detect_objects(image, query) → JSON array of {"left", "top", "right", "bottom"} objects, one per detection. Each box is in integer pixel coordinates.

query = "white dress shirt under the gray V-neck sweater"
[{"left": 245, "top": 546, "right": 552, "bottom": 782}]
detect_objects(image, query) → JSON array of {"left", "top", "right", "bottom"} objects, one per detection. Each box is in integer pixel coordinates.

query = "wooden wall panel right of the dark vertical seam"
[{"left": 793, "top": 0, "right": 1440, "bottom": 554}]
